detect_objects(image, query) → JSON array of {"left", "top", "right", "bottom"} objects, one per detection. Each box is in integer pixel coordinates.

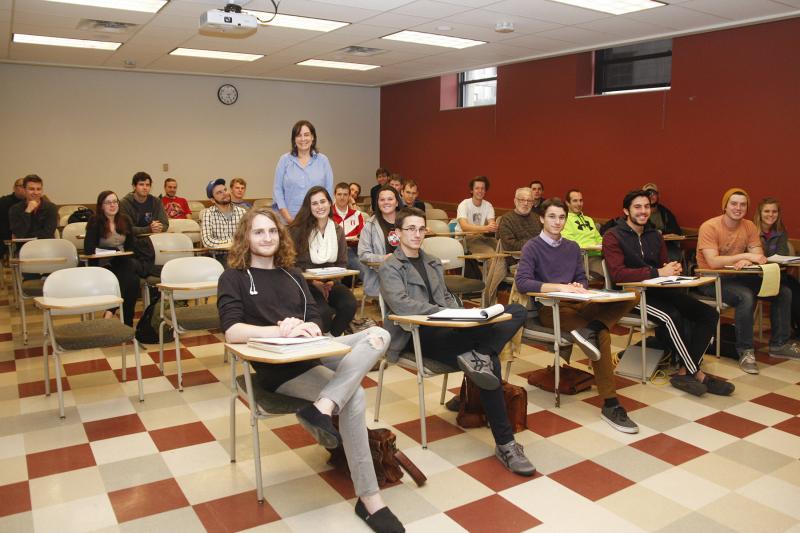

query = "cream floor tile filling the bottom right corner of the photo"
[{"left": 700, "top": 493, "right": 796, "bottom": 533}]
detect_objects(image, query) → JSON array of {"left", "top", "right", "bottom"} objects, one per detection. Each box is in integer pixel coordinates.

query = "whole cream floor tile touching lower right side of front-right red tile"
[{"left": 597, "top": 485, "right": 690, "bottom": 531}]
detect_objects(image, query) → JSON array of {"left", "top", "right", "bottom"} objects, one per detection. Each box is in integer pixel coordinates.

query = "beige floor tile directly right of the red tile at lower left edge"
[{"left": 28, "top": 467, "right": 106, "bottom": 509}]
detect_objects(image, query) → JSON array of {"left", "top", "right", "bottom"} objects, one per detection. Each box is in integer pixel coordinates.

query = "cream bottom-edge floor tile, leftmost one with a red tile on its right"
[{"left": 33, "top": 494, "right": 117, "bottom": 533}]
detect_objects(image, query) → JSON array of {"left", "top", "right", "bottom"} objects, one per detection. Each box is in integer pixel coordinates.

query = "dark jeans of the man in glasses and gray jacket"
[{"left": 419, "top": 304, "right": 527, "bottom": 444}]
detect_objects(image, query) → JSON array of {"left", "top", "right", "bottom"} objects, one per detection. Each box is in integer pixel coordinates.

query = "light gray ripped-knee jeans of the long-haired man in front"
[{"left": 275, "top": 327, "right": 389, "bottom": 496}]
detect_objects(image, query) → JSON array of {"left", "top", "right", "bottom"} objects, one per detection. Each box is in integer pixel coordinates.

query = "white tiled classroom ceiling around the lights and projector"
[{"left": 0, "top": 0, "right": 800, "bottom": 86}]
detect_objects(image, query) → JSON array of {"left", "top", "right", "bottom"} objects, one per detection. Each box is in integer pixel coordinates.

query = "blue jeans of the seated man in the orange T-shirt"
[{"left": 699, "top": 274, "right": 792, "bottom": 355}]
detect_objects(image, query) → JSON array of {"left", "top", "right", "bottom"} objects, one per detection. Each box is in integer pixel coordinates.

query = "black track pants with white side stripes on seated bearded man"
[{"left": 647, "top": 289, "right": 719, "bottom": 374}]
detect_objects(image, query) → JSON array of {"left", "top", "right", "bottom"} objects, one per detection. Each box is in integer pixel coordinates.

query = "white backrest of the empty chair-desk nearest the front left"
[{"left": 42, "top": 267, "right": 120, "bottom": 315}]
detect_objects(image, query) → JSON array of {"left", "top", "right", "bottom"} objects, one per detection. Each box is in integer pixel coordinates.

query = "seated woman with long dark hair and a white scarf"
[{"left": 289, "top": 185, "right": 358, "bottom": 337}]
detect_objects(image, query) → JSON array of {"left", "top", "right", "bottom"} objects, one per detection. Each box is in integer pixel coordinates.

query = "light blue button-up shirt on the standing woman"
[{"left": 272, "top": 152, "right": 333, "bottom": 217}]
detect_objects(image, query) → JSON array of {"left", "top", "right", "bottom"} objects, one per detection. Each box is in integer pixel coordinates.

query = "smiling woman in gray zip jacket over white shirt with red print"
[{"left": 358, "top": 185, "right": 400, "bottom": 297}]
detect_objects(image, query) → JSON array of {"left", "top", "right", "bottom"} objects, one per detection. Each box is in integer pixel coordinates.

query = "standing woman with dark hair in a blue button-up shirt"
[{"left": 272, "top": 120, "right": 333, "bottom": 223}]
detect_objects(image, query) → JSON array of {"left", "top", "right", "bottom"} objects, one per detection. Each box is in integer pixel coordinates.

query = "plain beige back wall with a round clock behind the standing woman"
[{"left": 0, "top": 64, "right": 380, "bottom": 204}]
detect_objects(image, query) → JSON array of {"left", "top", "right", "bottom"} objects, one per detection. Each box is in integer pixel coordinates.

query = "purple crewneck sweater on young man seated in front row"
[{"left": 516, "top": 236, "right": 589, "bottom": 293}]
